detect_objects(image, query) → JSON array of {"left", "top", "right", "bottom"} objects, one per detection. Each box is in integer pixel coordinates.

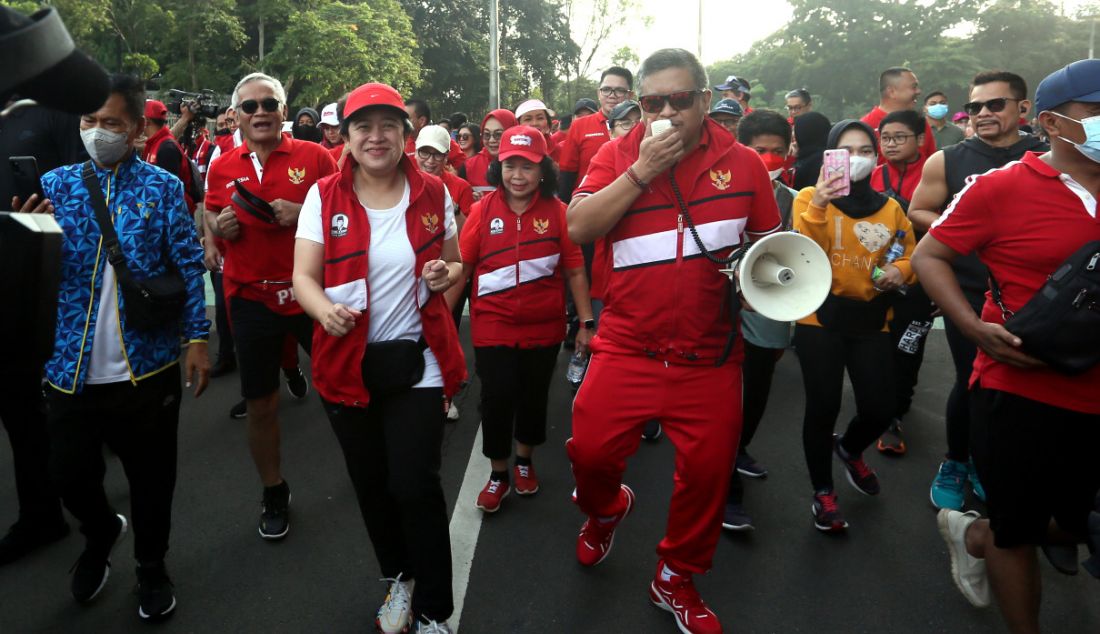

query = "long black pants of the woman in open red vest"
[{"left": 323, "top": 387, "right": 454, "bottom": 622}]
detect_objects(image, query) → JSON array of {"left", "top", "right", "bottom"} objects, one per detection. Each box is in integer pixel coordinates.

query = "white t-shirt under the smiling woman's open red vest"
[{"left": 295, "top": 181, "right": 459, "bottom": 387}]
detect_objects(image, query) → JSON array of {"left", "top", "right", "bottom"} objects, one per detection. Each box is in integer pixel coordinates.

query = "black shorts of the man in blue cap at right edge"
[{"left": 970, "top": 386, "right": 1100, "bottom": 548}]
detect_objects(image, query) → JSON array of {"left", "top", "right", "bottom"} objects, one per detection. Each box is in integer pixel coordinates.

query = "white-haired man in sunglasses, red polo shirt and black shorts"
[{"left": 206, "top": 73, "right": 336, "bottom": 539}]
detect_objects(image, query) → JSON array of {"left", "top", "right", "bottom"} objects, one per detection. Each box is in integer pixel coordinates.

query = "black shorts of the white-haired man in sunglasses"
[{"left": 229, "top": 297, "right": 314, "bottom": 398}]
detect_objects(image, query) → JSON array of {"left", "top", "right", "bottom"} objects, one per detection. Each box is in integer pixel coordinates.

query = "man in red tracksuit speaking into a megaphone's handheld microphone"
[{"left": 567, "top": 48, "right": 780, "bottom": 634}]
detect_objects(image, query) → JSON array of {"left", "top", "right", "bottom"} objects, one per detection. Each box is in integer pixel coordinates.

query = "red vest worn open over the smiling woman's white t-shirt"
[{"left": 312, "top": 157, "right": 466, "bottom": 407}]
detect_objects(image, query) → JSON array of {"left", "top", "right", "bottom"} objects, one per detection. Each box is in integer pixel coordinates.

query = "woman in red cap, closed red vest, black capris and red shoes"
[{"left": 461, "top": 125, "right": 595, "bottom": 513}]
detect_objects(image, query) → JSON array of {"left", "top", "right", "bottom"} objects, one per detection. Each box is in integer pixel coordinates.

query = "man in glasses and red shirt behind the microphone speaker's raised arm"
[{"left": 558, "top": 66, "right": 634, "bottom": 203}]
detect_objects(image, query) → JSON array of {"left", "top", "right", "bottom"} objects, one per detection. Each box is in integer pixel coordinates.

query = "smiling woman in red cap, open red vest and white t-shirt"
[{"left": 294, "top": 84, "right": 466, "bottom": 633}]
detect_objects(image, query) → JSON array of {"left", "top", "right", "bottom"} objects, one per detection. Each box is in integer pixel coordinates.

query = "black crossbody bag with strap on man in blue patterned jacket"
[{"left": 83, "top": 161, "right": 187, "bottom": 330}]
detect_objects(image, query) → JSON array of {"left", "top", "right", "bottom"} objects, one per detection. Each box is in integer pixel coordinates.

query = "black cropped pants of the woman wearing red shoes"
[{"left": 474, "top": 343, "right": 561, "bottom": 460}]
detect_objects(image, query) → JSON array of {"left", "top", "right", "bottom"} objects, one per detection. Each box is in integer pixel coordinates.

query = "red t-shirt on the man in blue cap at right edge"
[{"left": 928, "top": 153, "right": 1100, "bottom": 414}]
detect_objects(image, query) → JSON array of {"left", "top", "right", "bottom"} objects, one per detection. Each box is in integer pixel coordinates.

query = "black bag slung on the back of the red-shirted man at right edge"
[{"left": 989, "top": 240, "right": 1100, "bottom": 374}]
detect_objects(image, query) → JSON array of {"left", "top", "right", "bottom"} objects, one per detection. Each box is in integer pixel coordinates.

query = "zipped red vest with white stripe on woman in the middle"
[{"left": 470, "top": 189, "right": 567, "bottom": 348}]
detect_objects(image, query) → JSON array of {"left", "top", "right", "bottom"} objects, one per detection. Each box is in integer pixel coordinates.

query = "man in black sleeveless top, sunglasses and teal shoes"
[{"left": 909, "top": 70, "right": 1049, "bottom": 511}]
